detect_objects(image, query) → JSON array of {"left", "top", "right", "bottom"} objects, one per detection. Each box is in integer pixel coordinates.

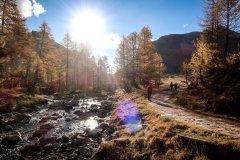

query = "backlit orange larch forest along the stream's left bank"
[{"left": 0, "top": 1, "right": 111, "bottom": 94}]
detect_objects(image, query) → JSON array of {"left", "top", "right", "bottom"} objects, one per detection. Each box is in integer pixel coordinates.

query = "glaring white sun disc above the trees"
[{"left": 70, "top": 9, "right": 105, "bottom": 44}]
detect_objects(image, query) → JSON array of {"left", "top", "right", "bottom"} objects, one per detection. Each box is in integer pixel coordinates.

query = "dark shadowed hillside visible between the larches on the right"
[{"left": 153, "top": 32, "right": 201, "bottom": 73}]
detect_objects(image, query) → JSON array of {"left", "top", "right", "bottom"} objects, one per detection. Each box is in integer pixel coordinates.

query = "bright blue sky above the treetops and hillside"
[{"left": 18, "top": 0, "right": 203, "bottom": 68}]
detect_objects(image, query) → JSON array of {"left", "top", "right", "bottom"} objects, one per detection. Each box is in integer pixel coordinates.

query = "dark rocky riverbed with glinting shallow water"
[{"left": 0, "top": 93, "right": 114, "bottom": 160}]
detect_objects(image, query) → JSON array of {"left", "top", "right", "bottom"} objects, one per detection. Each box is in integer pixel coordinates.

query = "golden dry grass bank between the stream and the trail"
[{"left": 92, "top": 92, "right": 240, "bottom": 160}]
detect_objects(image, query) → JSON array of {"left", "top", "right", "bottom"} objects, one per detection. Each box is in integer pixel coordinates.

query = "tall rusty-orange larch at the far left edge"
[{"left": 0, "top": 0, "right": 31, "bottom": 87}]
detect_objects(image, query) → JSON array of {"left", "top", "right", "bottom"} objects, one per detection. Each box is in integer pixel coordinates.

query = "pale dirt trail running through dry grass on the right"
[{"left": 149, "top": 91, "right": 240, "bottom": 138}]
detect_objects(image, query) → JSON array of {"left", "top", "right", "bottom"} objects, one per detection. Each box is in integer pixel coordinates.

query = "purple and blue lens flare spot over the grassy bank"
[{"left": 116, "top": 99, "right": 142, "bottom": 134}]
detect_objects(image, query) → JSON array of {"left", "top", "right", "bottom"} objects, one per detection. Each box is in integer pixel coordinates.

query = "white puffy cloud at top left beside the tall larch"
[{"left": 17, "top": 0, "right": 46, "bottom": 18}]
